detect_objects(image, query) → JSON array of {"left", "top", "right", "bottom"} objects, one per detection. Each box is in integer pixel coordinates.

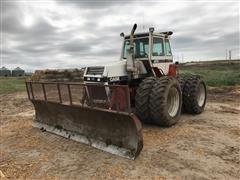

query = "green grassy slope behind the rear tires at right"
[{"left": 178, "top": 63, "right": 240, "bottom": 87}]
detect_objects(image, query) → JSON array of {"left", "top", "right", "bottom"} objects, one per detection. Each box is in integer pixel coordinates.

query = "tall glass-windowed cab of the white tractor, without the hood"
[{"left": 120, "top": 28, "right": 173, "bottom": 76}]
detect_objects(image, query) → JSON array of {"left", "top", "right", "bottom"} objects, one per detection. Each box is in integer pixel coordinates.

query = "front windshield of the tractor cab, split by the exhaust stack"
[{"left": 123, "top": 38, "right": 149, "bottom": 59}]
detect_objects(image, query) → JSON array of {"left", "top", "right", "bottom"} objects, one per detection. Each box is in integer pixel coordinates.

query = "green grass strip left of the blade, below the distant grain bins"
[{"left": 0, "top": 77, "right": 26, "bottom": 94}]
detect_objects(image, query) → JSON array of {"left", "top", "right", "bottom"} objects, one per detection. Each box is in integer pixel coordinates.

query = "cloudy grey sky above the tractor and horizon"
[{"left": 0, "top": 0, "right": 240, "bottom": 71}]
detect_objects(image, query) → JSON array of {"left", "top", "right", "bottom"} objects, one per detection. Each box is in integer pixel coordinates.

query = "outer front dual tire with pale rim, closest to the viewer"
[{"left": 149, "top": 76, "right": 182, "bottom": 127}]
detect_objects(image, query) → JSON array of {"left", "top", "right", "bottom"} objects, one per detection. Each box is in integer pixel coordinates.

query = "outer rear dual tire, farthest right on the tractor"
[{"left": 183, "top": 76, "right": 207, "bottom": 114}]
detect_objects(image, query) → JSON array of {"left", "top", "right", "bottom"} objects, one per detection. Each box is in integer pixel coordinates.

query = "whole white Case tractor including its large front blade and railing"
[{"left": 26, "top": 24, "right": 206, "bottom": 159}]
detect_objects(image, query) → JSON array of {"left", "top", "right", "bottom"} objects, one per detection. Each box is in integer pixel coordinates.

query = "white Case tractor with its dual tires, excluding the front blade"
[{"left": 84, "top": 24, "right": 206, "bottom": 126}]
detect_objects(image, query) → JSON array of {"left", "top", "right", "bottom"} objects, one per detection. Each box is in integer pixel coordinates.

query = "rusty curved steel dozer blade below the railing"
[{"left": 31, "top": 100, "right": 143, "bottom": 159}]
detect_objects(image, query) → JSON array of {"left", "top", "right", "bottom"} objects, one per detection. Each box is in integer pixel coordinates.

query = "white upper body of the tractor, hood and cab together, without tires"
[{"left": 84, "top": 24, "right": 176, "bottom": 84}]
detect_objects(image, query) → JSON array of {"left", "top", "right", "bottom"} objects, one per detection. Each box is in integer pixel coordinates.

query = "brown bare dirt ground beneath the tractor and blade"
[{"left": 0, "top": 87, "right": 240, "bottom": 179}]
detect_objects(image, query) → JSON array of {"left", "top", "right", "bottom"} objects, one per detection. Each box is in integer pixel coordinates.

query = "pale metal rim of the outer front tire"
[{"left": 167, "top": 87, "right": 180, "bottom": 117}]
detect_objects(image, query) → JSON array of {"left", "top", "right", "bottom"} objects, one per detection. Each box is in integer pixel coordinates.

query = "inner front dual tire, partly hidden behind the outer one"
[{"left": 135, "top": 77, "right": 157, "bottom": 123}]
